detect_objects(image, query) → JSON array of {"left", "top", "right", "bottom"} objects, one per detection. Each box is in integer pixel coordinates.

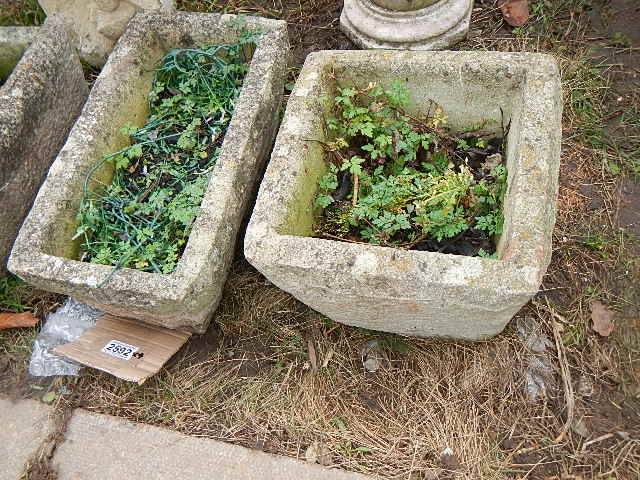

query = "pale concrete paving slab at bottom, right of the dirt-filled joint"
[{"left": 52, "top": 410, "right": 370, "bottom": 480}]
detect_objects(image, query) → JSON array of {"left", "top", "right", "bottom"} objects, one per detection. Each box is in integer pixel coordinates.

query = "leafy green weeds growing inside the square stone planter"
[{"left": 315, "top": 82, "right": 507, "bottom": 256}]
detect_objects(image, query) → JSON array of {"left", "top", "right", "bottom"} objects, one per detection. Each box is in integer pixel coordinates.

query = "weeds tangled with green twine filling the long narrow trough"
[{"left": 74, "top": 34, "right": 255, "bottom": 283}]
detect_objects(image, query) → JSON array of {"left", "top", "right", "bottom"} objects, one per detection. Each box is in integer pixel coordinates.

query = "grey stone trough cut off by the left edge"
[{"left": 0, "top": 18, "right": 88, "bottom": 275}]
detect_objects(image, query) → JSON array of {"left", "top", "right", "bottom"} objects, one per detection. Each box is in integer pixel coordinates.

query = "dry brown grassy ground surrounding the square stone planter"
[{"left": 0, "top": 0, "right": 640, "bottom": 480}]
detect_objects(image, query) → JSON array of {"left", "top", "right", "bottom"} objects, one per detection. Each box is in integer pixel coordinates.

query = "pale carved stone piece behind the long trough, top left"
[{"left": 38, "top": 0, "right": 175, "bottom": 66}]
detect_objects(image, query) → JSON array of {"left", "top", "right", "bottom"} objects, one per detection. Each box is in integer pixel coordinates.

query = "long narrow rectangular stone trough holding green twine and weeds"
[{"left": 9, "top": 12, "right": 288, "bottom": 332}]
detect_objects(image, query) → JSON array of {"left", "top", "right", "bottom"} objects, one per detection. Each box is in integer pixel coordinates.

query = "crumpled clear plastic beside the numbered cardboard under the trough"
[{"left": 29, "top": 298, "right": 102, "bottom": 377}]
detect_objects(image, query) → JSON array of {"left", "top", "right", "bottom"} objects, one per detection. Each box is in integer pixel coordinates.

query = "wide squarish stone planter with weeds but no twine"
[{"left": 245, "top": 51, "right": 562, "bottom": 340}]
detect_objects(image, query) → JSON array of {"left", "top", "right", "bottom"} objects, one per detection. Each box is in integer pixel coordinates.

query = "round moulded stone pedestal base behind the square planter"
[{"left": 340, "top": 0, "right": 473, "bottom": 50}]
